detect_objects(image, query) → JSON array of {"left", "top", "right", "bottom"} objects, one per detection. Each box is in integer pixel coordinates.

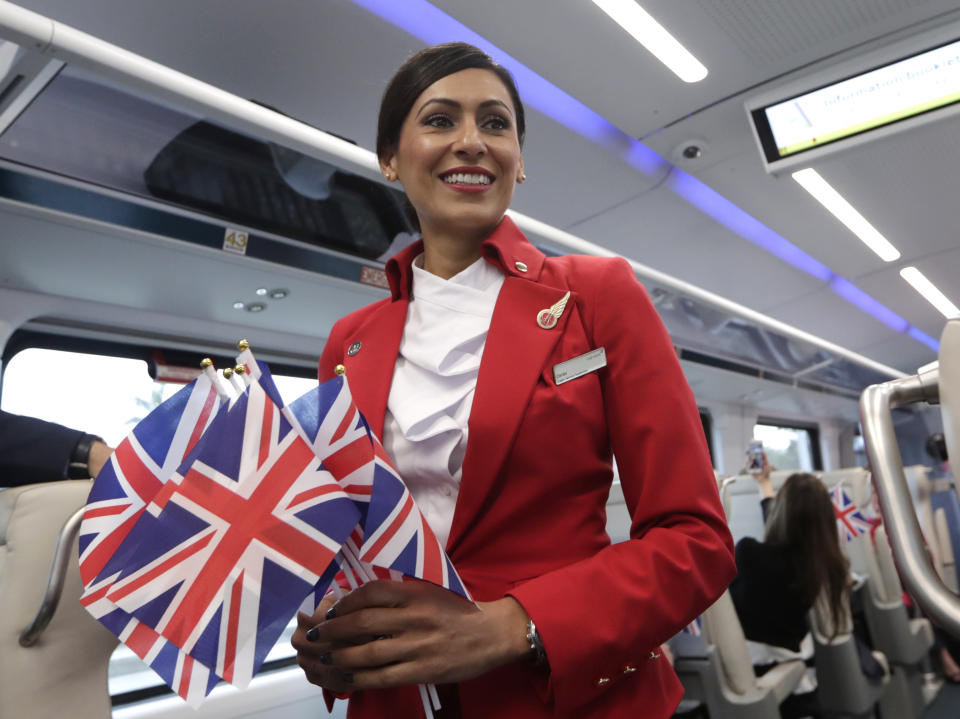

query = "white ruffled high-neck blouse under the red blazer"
[{"left": 383, "top": 255, "right": 504, "bottom": 546}]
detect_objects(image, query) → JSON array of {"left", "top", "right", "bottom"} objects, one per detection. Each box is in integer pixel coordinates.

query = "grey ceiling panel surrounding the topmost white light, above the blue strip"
[{"left": 433, "top": 0, "right": 957, "bottom": 137}]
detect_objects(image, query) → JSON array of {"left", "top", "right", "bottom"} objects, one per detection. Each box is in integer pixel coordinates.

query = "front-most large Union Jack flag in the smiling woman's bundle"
[{"left": 106, "top": 381, "right": 359, "bottom": 687}]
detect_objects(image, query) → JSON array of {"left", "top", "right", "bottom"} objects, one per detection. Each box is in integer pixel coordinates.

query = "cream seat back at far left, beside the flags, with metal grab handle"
[{"left": 0, "top": 480, "right": 117, "bottom": 719}]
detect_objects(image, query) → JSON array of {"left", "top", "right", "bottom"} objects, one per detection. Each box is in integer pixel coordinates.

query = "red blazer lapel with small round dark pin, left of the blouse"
[{"left": 343, "top": 299, "right": 409, "bottom": 440}]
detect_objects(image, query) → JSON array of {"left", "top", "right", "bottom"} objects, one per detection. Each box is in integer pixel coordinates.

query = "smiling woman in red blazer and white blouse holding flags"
[{"left": 293, "top": 43, "right": 733, "bottom": 719}]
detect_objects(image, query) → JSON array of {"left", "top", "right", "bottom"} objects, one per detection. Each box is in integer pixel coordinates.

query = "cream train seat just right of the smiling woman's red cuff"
[{"left": 674, "top": 591, "right": 806, "bottom": 719}]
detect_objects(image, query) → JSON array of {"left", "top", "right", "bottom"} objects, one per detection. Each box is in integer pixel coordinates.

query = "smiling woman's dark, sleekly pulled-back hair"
[{"left": 377, "top": 42, "right": 526, "bottom": 159}]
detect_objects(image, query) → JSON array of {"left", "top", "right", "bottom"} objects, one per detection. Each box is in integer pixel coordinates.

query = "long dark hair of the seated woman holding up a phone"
[{"left": 766, "top": 472, "right": 850, "bottom": 638}]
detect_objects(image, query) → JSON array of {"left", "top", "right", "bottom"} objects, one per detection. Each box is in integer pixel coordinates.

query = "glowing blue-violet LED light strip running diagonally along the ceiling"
[{"left": 351, "top": 0, "right": 940, "bottom": 352}]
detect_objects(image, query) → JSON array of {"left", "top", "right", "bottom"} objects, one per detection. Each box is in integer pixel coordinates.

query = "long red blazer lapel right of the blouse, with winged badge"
[{"left": 447, "top": 277, "right": 574, "bottom": 553}]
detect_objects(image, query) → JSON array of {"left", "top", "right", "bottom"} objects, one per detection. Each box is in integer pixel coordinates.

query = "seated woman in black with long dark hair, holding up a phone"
[{"left": 730, "top": 462, "right": 849, "bottom": 718}]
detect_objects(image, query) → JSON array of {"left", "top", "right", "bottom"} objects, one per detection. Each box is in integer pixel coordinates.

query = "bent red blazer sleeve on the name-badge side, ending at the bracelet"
[{"left": 509, "top": 260, "right": 736, "bottom": 716}]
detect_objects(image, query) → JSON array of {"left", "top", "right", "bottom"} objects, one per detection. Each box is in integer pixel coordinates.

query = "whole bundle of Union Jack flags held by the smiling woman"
[{"left": 79, "top": 344, "right": 469, "bottom": 716}]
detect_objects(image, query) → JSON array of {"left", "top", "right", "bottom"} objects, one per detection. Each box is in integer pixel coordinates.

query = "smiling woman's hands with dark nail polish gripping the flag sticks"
[{"left": 292, "top": 581, "right": 529, "bottom": 692}]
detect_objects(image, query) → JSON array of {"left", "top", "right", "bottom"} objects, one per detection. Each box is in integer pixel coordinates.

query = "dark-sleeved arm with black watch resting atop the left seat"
[{"left": 0, "top": 411, "right": 113, "bottom": 487}]
